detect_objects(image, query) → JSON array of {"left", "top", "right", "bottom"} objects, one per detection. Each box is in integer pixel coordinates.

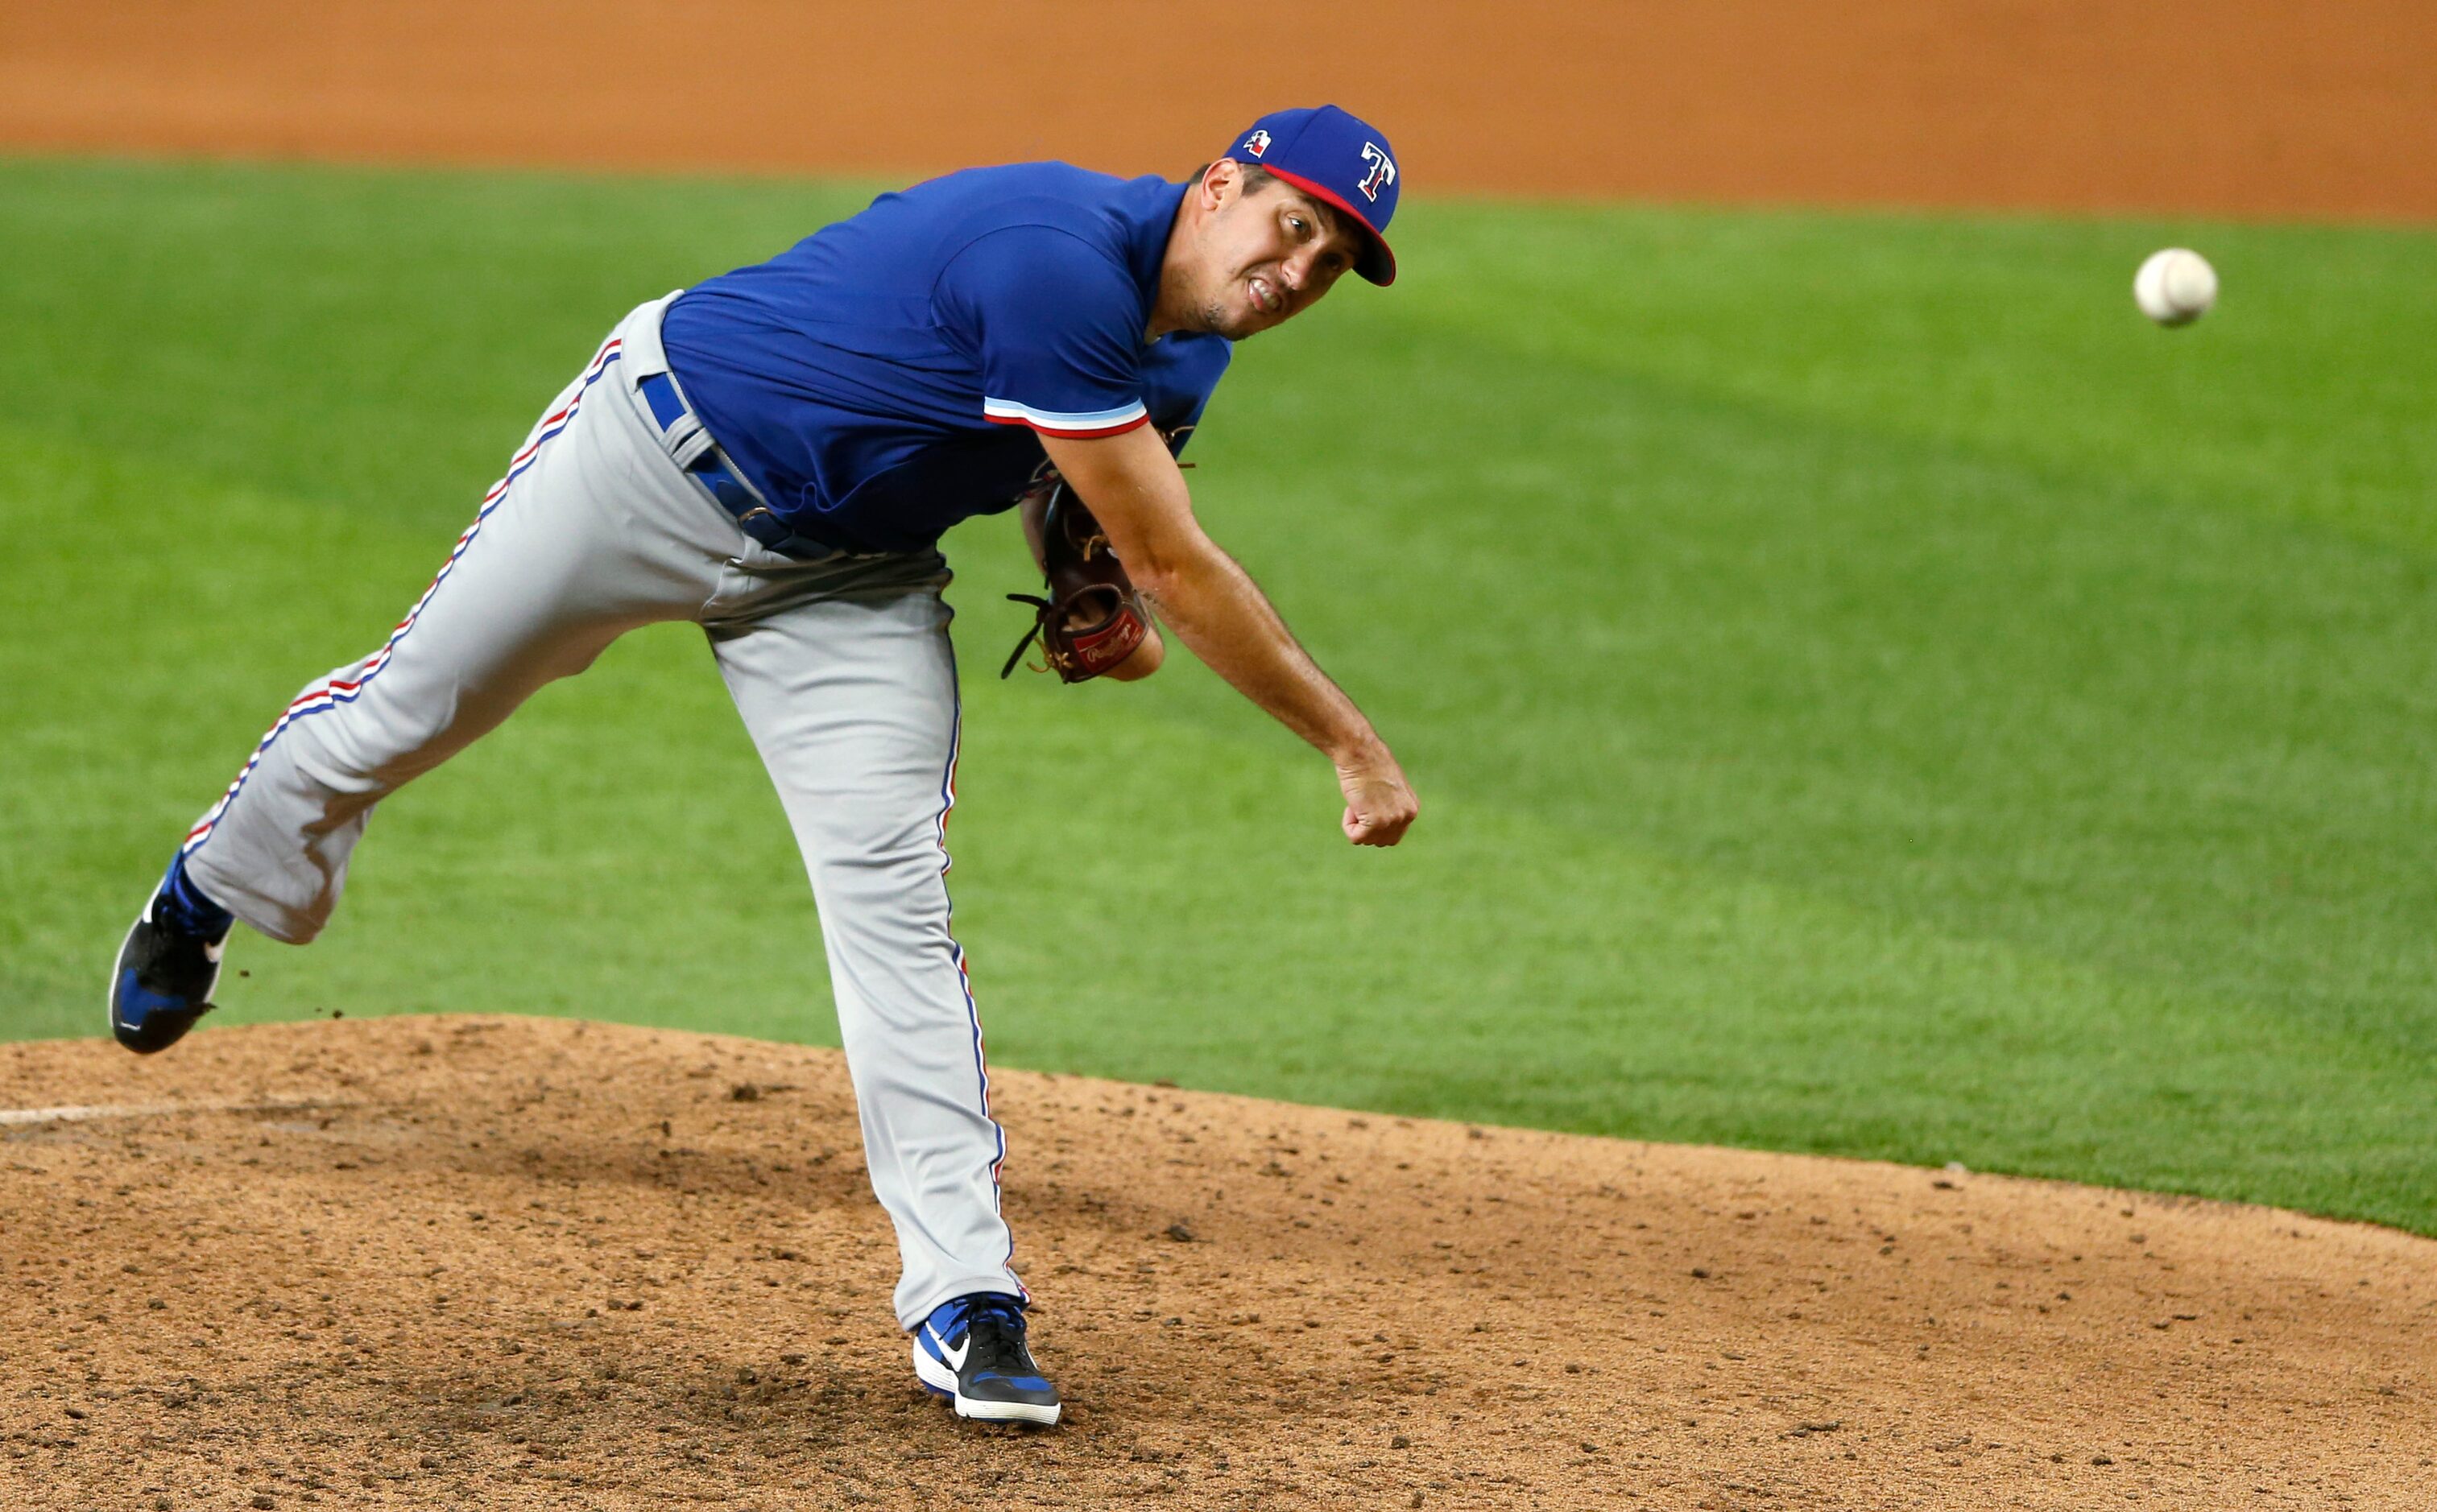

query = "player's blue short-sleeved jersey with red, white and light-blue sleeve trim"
[{"left": 660, "top": 163, "right": 1233, "bottom": 550}]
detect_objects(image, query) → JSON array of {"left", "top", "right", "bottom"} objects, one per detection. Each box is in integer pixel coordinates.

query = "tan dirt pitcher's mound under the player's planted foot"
[{"left": 0, "top": 1018, "right": 2437, "bottom": 1512}]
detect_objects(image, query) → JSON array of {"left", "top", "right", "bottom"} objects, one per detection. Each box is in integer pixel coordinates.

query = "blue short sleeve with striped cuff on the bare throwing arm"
[{"left": 933, "top": 226, "right": 1150, "bottom": 436}]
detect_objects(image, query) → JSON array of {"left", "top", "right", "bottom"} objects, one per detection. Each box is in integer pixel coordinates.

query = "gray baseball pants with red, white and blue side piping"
[{"left": 185, "top": 295, "right": 1024, "bottom": 1329}]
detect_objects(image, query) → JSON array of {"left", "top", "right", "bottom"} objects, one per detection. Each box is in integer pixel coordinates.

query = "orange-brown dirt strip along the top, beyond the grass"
[{"left": 0, "top": 0, "right": 2437, "bottom": 219}]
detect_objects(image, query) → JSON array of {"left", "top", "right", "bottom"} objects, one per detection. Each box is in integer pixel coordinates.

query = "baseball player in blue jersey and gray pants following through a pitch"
[{"left": 110, "top": 105, "right": 1416, "bottom": 1424}]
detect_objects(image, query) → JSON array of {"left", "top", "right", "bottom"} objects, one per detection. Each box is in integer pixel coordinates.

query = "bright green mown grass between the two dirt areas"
[{"left": 0, "top": 161, "right": 2437, "bottom": 1232}]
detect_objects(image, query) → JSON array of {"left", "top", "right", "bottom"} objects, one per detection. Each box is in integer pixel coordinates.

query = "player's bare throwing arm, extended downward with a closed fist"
[{"left": 1041, "top": 426, "right": 1421, "bottom": 845}]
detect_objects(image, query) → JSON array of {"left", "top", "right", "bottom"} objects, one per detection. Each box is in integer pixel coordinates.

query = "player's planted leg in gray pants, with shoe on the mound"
[{"left": 707, "top": 547, "right": 1057, "bottom": 1422}]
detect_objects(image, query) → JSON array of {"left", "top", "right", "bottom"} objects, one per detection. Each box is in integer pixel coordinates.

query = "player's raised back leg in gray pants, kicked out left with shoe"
[{"left": 110, "top": 299, "right": 734, "bottom": 1051}]
